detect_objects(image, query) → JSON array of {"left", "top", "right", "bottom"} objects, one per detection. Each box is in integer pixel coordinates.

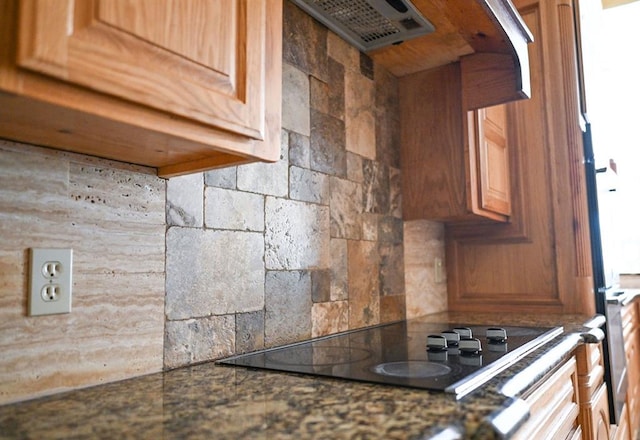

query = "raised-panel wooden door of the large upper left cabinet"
[{"left": 18, "top": 0, "right": 268, "bottom": 139}]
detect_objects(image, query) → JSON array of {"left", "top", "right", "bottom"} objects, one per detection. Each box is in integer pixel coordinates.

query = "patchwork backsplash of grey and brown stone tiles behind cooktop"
[{"left": 165, "top": 2, "right": 406, "bottom": 368}]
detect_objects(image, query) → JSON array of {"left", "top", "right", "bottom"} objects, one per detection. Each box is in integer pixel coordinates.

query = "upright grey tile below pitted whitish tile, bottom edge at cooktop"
[{"left": 264, "top": 271, "right": 312, "bottom": 346}]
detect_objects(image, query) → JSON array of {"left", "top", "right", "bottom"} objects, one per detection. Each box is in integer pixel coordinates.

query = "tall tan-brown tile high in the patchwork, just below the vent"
[{"left": 344, "top": 71, "right": 376, "bottom": 159}]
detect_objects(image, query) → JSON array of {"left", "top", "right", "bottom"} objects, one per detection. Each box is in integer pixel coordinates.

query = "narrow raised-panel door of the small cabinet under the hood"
[{"left": 476, "top": 105, "right": 511, "bottom": 215}]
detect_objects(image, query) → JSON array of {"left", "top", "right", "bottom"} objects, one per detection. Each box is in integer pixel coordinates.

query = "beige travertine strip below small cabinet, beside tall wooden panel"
[{"left": 404, "top": 220, "right": 447, "bottom": 318}]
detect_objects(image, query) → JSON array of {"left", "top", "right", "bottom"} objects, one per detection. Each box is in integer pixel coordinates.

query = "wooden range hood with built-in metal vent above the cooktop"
[{"left": 291, "top": 0, "right": 533, "bottom": 110}]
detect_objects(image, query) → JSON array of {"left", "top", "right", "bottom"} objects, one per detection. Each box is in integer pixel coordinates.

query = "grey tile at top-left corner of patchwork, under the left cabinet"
[{"left": 167, "top": 173, "right": 204, "bottom": 227}]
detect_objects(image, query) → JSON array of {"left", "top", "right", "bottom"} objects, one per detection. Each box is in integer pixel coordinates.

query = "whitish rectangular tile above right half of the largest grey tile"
[{"left": 204, "top": 187, "right": 264, "bottom": 231}]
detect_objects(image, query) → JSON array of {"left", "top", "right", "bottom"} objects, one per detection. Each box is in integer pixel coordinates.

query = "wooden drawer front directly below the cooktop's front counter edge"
[{"left": 514, "top": 358, "right": 579, "bottom": 440}]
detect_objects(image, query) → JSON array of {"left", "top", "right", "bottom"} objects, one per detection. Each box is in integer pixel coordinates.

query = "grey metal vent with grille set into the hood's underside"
[{"left": 293, "top": 0, "right": 435, "bottom": 52}]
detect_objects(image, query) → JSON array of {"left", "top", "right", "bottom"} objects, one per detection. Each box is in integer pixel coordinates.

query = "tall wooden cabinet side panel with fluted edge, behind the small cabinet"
[{"left": 444, "top": 0, "right": 595, "bottom": 315}]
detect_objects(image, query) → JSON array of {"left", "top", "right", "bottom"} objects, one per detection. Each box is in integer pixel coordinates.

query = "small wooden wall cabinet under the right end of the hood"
[{"left": 400, "top": 63, "right": 511, "bottom": 222}]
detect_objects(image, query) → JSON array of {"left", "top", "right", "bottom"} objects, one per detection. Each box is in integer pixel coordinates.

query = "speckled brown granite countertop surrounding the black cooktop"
[{"left": 0, "top": 313, "right": 603, "bottom": 439}]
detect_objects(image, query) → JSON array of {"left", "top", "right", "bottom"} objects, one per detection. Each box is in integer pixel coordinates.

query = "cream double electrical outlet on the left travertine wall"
[{"left": 29, "top": 249, "right": 73, "bottom": 316}]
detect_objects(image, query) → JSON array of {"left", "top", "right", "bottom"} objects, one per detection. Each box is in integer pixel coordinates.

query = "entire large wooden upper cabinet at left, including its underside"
[{"left": 0, "top": 0, "right": 282, "bottom": 176}]
